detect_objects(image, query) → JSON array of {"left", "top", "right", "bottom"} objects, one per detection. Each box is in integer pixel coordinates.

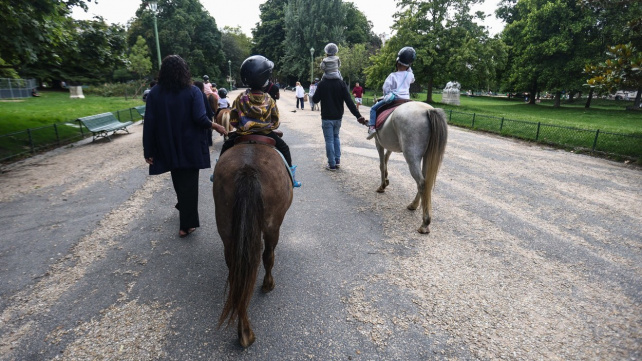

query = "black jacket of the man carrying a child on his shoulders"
[{"left": 312, "top": 78, "right": 361, "bottom": 120}]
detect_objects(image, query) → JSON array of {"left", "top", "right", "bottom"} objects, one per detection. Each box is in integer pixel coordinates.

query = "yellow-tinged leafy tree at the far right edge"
[{"left": 585, "top": 43, "right": 642, "bottom": 109}]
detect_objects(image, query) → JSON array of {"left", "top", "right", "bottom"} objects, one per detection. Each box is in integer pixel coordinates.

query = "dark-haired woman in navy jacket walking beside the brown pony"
[{"left": 143, "top": 55, "right": 226, "bottom": 237}]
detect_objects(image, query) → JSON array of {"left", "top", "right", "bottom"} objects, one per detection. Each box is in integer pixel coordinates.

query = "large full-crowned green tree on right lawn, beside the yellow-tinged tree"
[{"left": 498, "top": 0, "right": 597, "bottom": 106}]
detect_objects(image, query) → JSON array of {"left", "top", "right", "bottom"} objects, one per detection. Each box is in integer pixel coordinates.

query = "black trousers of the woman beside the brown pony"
[{"left": 171, "top": 169, "right": 201, "bottom": 231}]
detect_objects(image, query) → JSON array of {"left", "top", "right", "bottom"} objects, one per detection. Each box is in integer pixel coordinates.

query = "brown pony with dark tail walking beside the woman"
[{"left": 212, "top": 143, "right": 293, "bottom": 347}]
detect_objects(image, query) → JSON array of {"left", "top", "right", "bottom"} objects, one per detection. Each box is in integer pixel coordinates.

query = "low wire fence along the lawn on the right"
[{"left": 446, "top": 110, "right": 642, "bottom": 161}]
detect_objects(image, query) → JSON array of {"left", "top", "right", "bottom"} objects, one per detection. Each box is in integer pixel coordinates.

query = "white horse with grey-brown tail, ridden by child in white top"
[{"left": 375, "top": 102, "right": 448, "bottom": 233}]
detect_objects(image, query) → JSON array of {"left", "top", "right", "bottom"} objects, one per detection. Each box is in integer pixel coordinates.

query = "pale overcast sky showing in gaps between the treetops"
[{"left": 73, "top": 0, "right": 504, "bottom": 36}]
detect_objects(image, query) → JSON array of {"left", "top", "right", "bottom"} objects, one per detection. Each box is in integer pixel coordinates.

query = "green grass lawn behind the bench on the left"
[{"left": 0, "top": 91, "right": 144, "bottom": 135}]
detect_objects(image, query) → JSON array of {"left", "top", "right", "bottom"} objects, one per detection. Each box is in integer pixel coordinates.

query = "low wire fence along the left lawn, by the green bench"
[{"left": 0, "top": 108, "right": 141, "bottom": 162}]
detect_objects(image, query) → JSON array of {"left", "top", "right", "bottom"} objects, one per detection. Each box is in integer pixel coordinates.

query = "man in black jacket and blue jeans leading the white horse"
[{"left": 312, "top": 79, "right": 366, "bottom": 170}]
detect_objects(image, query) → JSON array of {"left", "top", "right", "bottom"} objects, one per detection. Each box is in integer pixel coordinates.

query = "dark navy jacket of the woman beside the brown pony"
[{"left": 143, "top": 85, "right": 212, "bottom": 175}]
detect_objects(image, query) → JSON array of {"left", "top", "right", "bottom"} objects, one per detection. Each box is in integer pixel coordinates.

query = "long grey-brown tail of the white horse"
[{"left": 421, "top": 109, "right": 448, "bottom": 215}]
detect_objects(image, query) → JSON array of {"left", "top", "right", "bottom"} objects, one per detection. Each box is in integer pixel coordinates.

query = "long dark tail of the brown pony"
[{"left": 218, "top": 166, "right": 264, "bottom": 327}]
